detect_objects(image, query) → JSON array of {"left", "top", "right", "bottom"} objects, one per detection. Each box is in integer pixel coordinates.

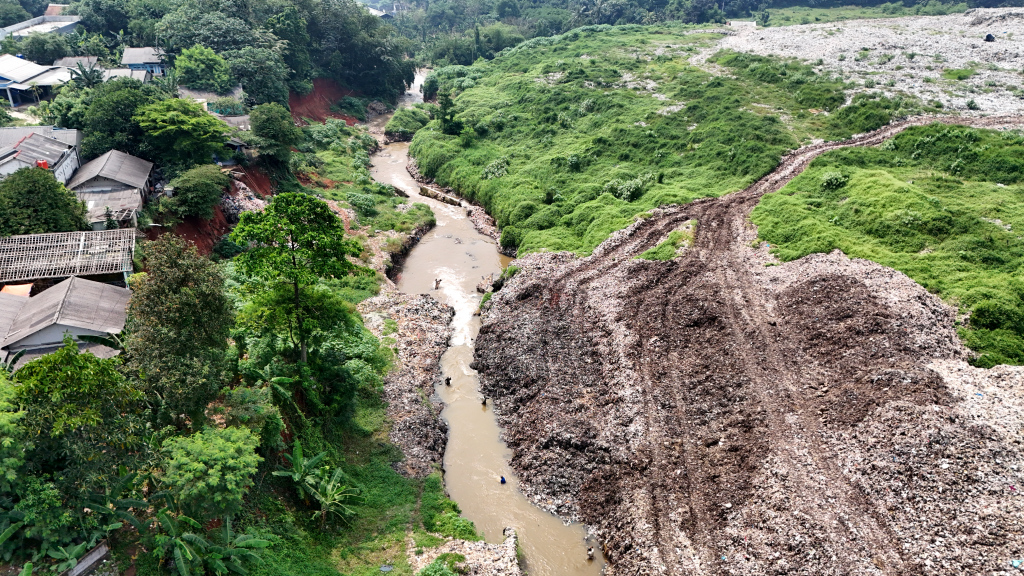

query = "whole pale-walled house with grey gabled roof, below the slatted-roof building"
[{"left": 0, "top": 277, "right": 131, "bottom": 361}]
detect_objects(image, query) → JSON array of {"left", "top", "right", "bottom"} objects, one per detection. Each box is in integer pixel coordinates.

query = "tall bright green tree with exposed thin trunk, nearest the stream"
[{"left": 231, "top": 193, "right": 361, "bottom": 363}]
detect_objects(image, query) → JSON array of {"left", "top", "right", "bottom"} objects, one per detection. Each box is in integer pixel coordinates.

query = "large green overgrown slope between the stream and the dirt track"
[{"left": 412, "top": 26, "right": 929, "bottom": 254}]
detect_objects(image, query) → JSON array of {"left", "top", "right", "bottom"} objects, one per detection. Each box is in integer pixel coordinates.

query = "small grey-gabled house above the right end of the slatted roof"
[{"left": 68, "top": 150, "right": 153, "bottom": 230}]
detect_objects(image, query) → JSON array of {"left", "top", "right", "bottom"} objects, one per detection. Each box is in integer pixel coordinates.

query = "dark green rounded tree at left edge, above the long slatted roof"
[{"left": 0, "top": 168, "right": 90, "bottom": 236}]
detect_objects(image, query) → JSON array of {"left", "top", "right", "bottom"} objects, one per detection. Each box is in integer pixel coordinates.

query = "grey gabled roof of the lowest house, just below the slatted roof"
[{"left": 0, "top": 277, "right": 131, "bottom": 347}]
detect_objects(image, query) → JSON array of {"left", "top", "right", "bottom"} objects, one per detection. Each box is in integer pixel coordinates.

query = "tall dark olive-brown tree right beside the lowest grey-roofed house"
[{"left": 125, "top": 235, "right": 231, "bottom": 425}]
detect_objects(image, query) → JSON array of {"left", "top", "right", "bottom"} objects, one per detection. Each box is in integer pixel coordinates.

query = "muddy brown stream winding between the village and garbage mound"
[{"left": 371, "top": 73, "right": 604, "bottom": 576}]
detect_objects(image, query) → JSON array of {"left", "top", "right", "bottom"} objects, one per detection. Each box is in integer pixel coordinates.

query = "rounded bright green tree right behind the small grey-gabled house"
[{"left": 134, "top": 98, "right": 228, "bottom": 168}]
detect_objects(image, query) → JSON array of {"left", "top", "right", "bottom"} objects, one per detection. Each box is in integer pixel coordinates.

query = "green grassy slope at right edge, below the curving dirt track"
[{"left": 752, "top": 124, "right": 1024, "bottom": 367}]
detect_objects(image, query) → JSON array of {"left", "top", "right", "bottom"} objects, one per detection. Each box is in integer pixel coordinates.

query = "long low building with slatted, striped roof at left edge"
[{"left": 0, "top": 229, "right": 135, "bottom": 284}]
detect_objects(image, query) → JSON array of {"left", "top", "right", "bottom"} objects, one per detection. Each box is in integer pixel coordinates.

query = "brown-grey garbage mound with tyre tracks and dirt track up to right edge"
[{"left": 474, "top": 117, "right": 1024, "bottom": 576}]
